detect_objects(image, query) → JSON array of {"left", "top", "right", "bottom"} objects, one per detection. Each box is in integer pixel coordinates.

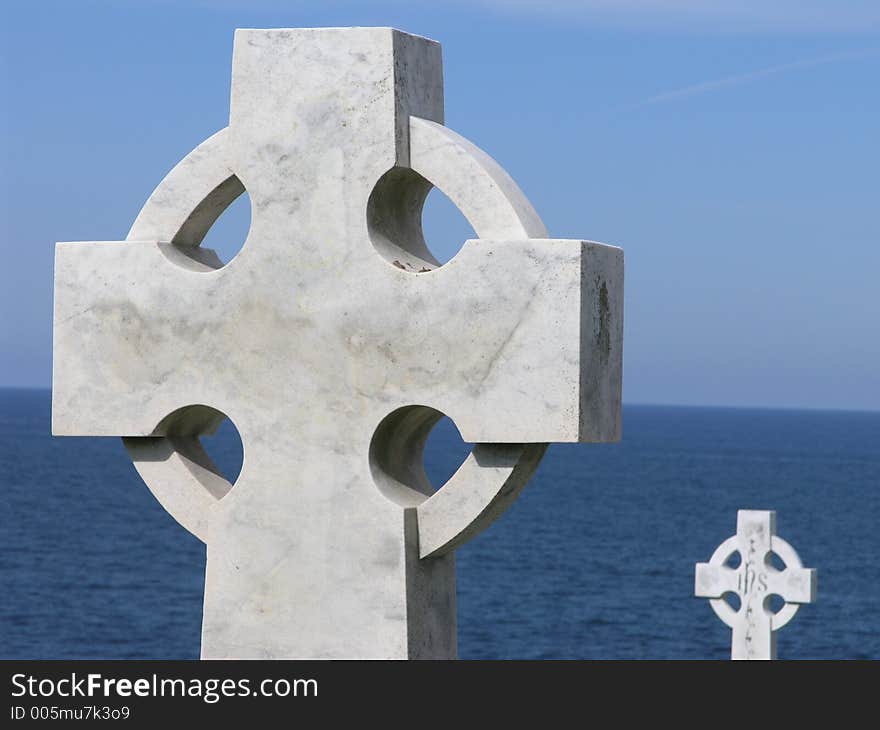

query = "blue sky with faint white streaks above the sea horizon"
[{"left": 0, "top": 0, "right": 880, "bottom": 410}]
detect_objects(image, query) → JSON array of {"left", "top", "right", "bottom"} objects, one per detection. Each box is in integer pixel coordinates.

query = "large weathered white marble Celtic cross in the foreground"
[{"left": 52, "top": 28, "right": 623, "bottom": 658}]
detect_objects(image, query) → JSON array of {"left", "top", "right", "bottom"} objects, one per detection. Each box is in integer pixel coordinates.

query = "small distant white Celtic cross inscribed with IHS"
[{"left": 694, "top": 510, "right": 816, "bottom": 659}]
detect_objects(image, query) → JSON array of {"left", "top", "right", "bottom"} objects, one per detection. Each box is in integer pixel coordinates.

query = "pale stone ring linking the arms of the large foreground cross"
[{"left": 125, "top": 117, "right": 560, "bottom": 558}]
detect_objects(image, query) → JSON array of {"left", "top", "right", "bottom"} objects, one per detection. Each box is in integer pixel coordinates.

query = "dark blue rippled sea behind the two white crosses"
[{"left": 0, "top": 390, "right": 880, "bottom": 659}]
